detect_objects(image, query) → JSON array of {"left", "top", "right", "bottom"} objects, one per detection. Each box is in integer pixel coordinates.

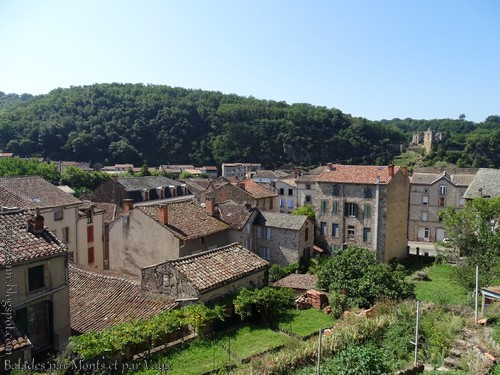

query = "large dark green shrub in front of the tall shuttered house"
[{"left": 318, "top": 246, "right": 413, "bottom": 307}]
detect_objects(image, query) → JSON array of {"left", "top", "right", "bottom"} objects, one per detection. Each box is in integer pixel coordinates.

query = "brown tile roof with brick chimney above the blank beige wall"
[{"left": 137, "top": 201, "right": 230, "bottom": 240}]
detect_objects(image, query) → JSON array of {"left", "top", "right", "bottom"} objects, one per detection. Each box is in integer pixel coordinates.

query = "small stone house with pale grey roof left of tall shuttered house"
[{"left": 255, "top": 211, "right": 314, "bottom": 266}]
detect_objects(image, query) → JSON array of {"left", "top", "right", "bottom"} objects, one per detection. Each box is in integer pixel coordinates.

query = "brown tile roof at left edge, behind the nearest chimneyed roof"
[{"left": 0, "top": 176, "right": 80, "bottom": 208}]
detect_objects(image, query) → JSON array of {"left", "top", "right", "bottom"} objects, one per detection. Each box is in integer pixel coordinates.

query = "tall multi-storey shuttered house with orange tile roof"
[{"left": 313, "top": 163, "right": 409, "bottom": 262}]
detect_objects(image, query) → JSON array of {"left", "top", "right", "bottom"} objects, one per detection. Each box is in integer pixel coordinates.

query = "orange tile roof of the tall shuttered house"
[{"left": 314, "top": 164, "right": 400, "bottom": 185}]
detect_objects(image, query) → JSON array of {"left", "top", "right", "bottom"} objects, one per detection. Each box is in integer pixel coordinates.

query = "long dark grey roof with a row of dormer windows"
[{"left": 92, "top": 176, "right": 191, "bottom": 204}]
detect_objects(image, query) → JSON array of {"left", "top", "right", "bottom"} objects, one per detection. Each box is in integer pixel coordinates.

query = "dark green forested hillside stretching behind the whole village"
[{"left": 0, "top": 84, "right": 500, "bottom": 168}]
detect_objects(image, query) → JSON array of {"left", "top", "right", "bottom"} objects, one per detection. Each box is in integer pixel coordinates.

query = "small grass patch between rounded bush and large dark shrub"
[{"left": 278, "top": 309, "right": 336, "bottom": 337}]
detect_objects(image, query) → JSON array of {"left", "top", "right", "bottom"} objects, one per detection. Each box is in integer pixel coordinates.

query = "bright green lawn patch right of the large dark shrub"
[{"left": 415, "top": 264, "right": 468, "bottom": 305}]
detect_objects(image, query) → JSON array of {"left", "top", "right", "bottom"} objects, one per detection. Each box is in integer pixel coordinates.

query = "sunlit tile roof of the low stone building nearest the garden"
[{"left": 169, "top": 243, "right": 269, "bottom": 292}]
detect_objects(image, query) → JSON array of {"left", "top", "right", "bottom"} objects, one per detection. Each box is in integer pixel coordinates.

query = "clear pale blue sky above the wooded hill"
[{"left": 0, "top": 0, "right": 500, "bottom": 122}]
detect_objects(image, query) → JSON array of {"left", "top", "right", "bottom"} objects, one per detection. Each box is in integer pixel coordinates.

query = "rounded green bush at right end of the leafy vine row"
[{"left": 233, "top": 287, "right": 294, "bottom": 321}]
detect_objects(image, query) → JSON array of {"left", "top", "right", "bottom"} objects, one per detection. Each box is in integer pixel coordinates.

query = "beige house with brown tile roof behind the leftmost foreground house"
[{"left": 0, "top": 176, "right": 86, "bottom": 256}]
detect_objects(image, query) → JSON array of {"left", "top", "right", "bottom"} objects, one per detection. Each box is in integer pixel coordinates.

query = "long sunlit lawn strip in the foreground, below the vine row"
[{"left": 133, "top": 326, "right": 290, "bottom": 375}]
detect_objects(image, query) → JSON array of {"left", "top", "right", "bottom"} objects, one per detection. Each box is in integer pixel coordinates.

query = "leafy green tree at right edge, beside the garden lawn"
[{"left": 443, "top": 197, "right": 500, "bottom": 290}]
